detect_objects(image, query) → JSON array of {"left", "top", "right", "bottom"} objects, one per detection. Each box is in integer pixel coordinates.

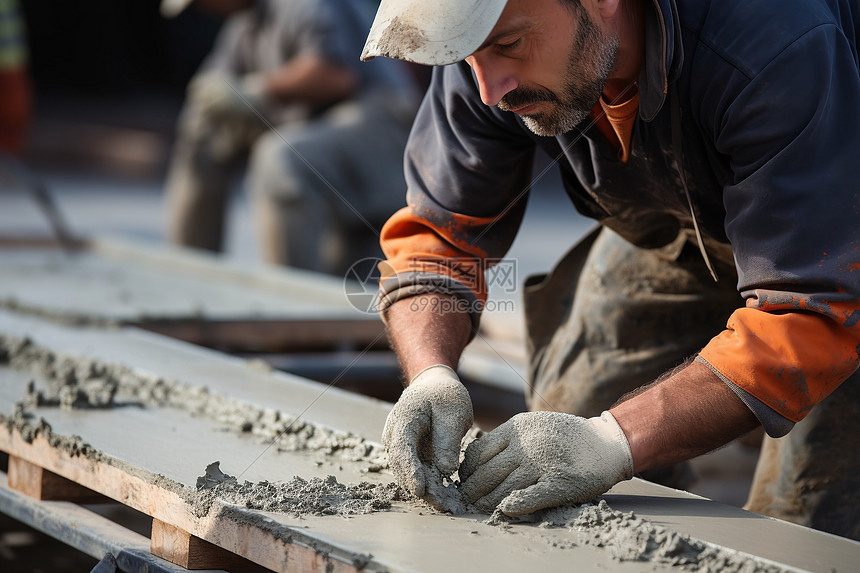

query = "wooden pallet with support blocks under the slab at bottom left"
[{"left": 0, "top": 444, "right": 350, "bottom": 573}]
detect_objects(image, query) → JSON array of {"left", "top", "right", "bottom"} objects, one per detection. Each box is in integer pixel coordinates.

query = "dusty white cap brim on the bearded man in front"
[{"left": 361, "top": 0, "right": 507, "bottom": 66}]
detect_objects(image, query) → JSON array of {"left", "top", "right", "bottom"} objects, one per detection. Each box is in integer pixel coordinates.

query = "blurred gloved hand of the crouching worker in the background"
[{"left": 187, "top": 71, "right": 266, "bottom": 117}]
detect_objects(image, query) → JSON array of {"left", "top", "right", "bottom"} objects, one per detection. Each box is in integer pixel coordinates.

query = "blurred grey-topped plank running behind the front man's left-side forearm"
[{"left": 0, "top": 237, "right": 536, "bottom": 391}]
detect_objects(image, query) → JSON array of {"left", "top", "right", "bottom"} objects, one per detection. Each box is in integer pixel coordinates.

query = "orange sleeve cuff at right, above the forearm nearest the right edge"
[{"left": 700, "top": 308, "right": 860, "bottom": 422}]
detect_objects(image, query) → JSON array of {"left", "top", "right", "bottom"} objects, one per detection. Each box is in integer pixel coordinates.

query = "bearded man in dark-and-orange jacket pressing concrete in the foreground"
[{"left": 362, "top": 0, "right": 860, "bottom": 539}]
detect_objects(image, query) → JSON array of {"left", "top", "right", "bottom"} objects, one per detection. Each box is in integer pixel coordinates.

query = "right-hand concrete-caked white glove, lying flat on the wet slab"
[{"left": 460, "top": 412, "right": 633, "bottom": 516}]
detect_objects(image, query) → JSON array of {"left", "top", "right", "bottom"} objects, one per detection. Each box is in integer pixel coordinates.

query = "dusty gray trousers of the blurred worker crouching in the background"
[{"left": 165, "top": 94, "right": 415, "bottom": 274}]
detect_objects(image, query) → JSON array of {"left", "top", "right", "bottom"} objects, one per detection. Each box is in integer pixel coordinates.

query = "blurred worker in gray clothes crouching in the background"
[{"left": 161, "top": 0, "right": 418, "bottom": 274}]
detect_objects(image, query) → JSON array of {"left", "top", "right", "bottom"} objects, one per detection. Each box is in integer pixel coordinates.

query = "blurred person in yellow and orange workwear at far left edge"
[{"left": 0, "top": 0, "right": 30, "bottom": 156}]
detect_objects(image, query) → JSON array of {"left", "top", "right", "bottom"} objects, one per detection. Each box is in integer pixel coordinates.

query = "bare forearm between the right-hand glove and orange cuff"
[{"left": 610, "top": 362, "right": 759, "bottom": 472}]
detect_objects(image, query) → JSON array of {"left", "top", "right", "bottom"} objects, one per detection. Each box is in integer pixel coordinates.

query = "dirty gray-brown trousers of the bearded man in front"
[{"left": 525, "top": 225, "right": 860, "bottom": 539}]
